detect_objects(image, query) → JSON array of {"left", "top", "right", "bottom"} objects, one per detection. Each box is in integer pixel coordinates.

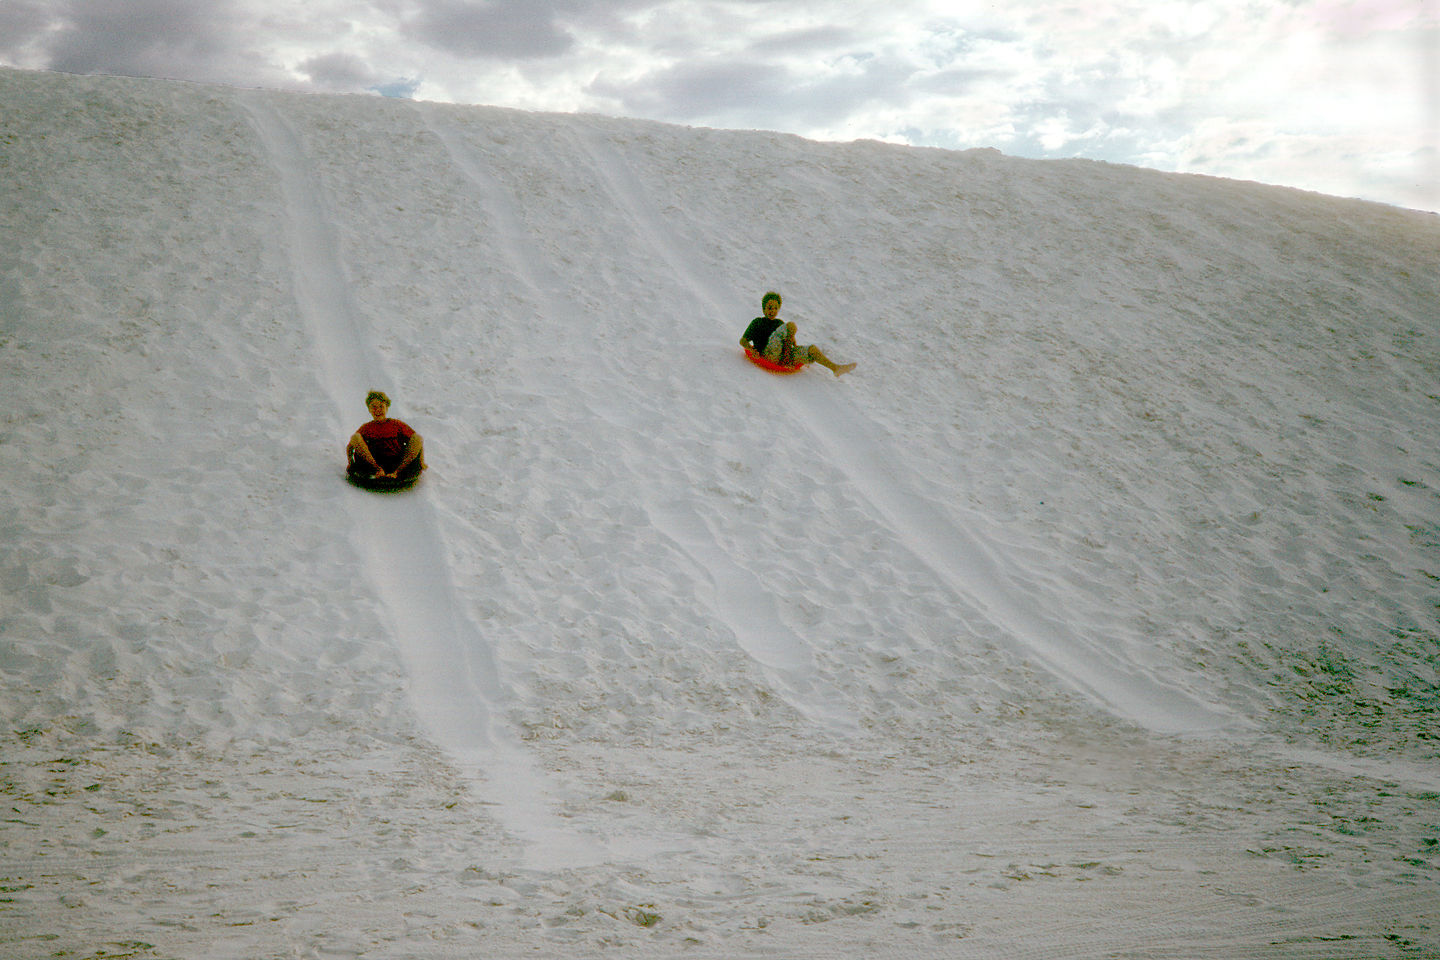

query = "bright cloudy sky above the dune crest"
[{"left": 8, "top": 0, "right": 1440, "bottom": 210}]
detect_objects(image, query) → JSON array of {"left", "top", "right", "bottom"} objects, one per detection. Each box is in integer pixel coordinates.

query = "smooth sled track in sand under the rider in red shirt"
[{"left": 242, "top": 95, "right": 598, "bottom": 866}]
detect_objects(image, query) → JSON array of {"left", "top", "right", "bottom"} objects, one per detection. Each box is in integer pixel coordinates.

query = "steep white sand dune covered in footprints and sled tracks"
[{"left": 0, "top": 63, "right": 1440, "bottom": 960}]
